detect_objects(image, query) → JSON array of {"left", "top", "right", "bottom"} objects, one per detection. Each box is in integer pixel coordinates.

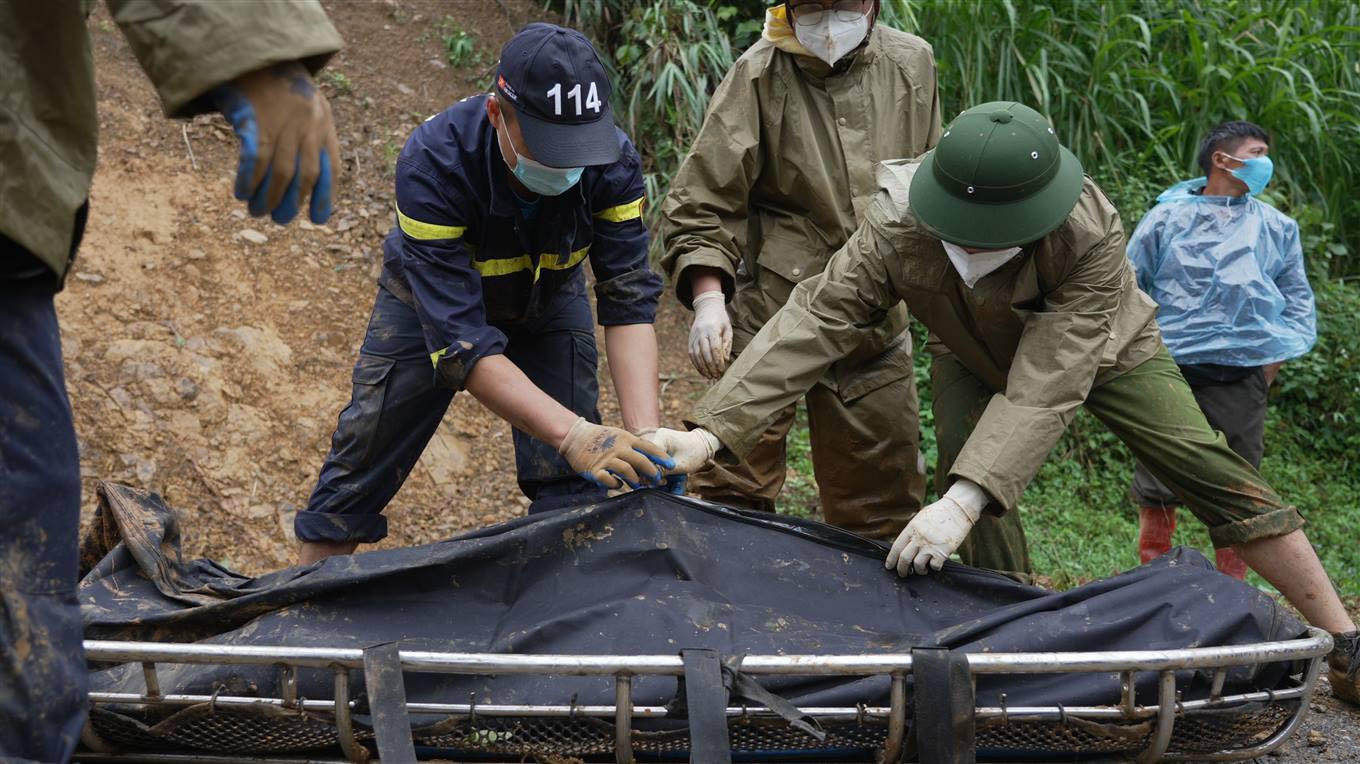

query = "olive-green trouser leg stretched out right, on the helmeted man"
[{"left": 1085, "top": 349, "right": 1303, "bottom": 546}]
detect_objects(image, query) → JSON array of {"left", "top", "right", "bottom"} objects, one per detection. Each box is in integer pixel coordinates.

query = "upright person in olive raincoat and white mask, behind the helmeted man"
[{"left": 661, "top": 0, "right": 940, "bottom": 538}]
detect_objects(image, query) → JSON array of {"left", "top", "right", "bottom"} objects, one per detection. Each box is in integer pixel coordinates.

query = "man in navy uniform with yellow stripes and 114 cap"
[{"left": 294, "top": 23, "right": 670, "bottom": 564}]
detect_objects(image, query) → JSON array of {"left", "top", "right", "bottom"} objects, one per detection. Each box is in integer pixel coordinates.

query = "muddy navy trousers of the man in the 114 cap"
[{"left": 294, "top": 280, "right": 605, "bottom": 542}]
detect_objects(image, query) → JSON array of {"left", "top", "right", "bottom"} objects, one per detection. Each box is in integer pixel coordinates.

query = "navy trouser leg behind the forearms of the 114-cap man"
[{"left": 506, "top": 292, "right": 607, "bottom": 514}]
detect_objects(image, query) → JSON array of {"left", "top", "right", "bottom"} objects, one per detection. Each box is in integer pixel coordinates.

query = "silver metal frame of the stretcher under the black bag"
[{"left": 76, "top": 628, "right": 1331, "bottom": 764}]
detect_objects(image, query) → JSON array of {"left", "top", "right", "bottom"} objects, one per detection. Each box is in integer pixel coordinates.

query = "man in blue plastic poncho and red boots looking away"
[{"left": 1127, "top": 121, "right": 1318, "bottom": 579}]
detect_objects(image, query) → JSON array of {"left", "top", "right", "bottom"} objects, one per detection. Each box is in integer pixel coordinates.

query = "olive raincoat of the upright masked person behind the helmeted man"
[{"left": 661, "top": 24, "right": 940, "bottom": 383}]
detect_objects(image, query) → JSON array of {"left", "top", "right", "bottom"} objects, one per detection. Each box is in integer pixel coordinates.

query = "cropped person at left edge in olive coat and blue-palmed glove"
[{"left": 0, "top": 0, "right": 341, "bottom": 761}]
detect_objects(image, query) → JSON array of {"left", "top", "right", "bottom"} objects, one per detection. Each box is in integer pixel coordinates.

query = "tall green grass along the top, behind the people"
[{"left": 549, "top": 0, "right": 1360, "bottom": 277}]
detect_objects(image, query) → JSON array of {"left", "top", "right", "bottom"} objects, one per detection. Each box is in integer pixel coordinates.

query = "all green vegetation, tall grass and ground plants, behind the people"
[{"left": 549, "top": 0, "right": 1360, "bottom": 598}]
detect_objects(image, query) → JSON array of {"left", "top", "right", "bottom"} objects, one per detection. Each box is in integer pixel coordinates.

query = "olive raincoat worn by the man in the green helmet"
[{"left": 694, "top": 160, "right": 1161, "bottom": 510}]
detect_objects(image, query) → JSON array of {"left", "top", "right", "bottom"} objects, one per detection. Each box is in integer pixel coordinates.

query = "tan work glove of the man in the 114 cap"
[{"left": 558, "top": 416, "right": 675, "bottom": 488}]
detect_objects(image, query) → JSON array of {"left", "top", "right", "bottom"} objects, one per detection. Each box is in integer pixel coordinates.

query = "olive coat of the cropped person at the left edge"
[{"left": 0, "top": 0, "right": 341, "bottom": 276}]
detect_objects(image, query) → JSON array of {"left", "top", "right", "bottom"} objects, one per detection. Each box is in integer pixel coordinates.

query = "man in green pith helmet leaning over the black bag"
[{"left": 644, "top": 102, "right": 1360, "bottom": 701}]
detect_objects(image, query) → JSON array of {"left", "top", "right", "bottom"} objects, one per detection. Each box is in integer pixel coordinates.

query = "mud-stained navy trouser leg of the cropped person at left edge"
[{"left": 0, "top": 288, "right": 87, "bottom": 761}]
